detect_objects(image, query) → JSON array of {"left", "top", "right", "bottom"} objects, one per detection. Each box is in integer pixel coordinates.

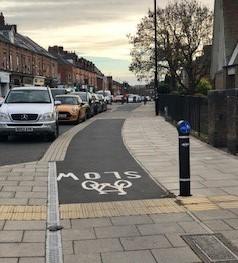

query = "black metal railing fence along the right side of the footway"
[{"left": 159, "top": 94, "right": 208, "bottom": 137}]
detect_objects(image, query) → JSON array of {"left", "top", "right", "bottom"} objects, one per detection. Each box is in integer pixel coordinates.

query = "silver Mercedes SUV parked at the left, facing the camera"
[{"left": 0, "top": 87, "right": 59, "bottom": 141}]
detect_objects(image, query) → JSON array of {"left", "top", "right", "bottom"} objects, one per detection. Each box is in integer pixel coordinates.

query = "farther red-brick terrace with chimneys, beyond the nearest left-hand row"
[{"left": 48, "top": 46, "right": 106, "bottom": 90}]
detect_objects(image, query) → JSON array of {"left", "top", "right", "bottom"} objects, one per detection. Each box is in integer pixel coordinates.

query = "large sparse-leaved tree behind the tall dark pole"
[{"left": 129, "top": 0, "right": 213, "bottom": 94}]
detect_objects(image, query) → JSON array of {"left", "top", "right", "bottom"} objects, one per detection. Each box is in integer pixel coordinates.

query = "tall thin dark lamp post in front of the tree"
[{"left": 154, "top": 0, "right": 159, "bottom": 116}]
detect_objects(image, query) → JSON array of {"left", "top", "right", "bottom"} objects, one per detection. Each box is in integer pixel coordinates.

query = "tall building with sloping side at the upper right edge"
[{"left": 211, "top": 0, "right": 238, "bottom": 90}]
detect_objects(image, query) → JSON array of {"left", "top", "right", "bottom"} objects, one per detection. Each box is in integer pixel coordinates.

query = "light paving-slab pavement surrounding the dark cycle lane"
[{"left": 0, "top": 103, "right": 238, "bottom": 263}]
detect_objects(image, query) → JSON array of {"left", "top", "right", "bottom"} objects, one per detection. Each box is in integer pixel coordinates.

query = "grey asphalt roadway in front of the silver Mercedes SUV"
[{"left": 0, "top": 125, "right": 73, "bottom": 166}]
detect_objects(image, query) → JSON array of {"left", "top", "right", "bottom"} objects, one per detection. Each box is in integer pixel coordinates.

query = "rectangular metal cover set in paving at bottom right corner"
[{"left": 182, "top": 234, "right": 238, "bottom": 263}]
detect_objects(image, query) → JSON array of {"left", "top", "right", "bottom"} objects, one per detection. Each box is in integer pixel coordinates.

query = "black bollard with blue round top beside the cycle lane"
[{"left": 177, "top": 120, "right": 191, "bottom": 196}]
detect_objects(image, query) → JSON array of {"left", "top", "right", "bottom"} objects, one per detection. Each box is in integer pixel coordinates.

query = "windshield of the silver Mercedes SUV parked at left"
[{"left": 6, "top": 90, "right": 51, "bottom": 103}]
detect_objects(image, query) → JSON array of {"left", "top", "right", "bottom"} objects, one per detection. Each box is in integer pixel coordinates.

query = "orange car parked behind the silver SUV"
[{"left": 55, "top": 94, "right": 87, "bottom": 123}]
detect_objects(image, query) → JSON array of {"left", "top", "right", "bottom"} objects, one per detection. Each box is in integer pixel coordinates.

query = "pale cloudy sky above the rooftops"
[{"left": 0, "top": 0, "right": 214, "bottom": 85}]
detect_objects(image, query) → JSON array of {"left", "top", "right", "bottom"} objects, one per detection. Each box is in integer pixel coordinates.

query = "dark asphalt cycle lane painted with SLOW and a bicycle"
[{"left": 57, "top": 118, "right": 165, "bottom": 204}]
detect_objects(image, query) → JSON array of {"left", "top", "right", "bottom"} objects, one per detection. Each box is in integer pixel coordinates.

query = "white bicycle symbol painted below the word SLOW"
[{"left": 82, "top": 180, "right": 132, "bottom": 195}]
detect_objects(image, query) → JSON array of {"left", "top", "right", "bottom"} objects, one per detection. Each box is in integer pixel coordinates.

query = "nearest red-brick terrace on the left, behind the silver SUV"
[{"left": 0, "top": 13, "right": 58, "bottom": 96}]
